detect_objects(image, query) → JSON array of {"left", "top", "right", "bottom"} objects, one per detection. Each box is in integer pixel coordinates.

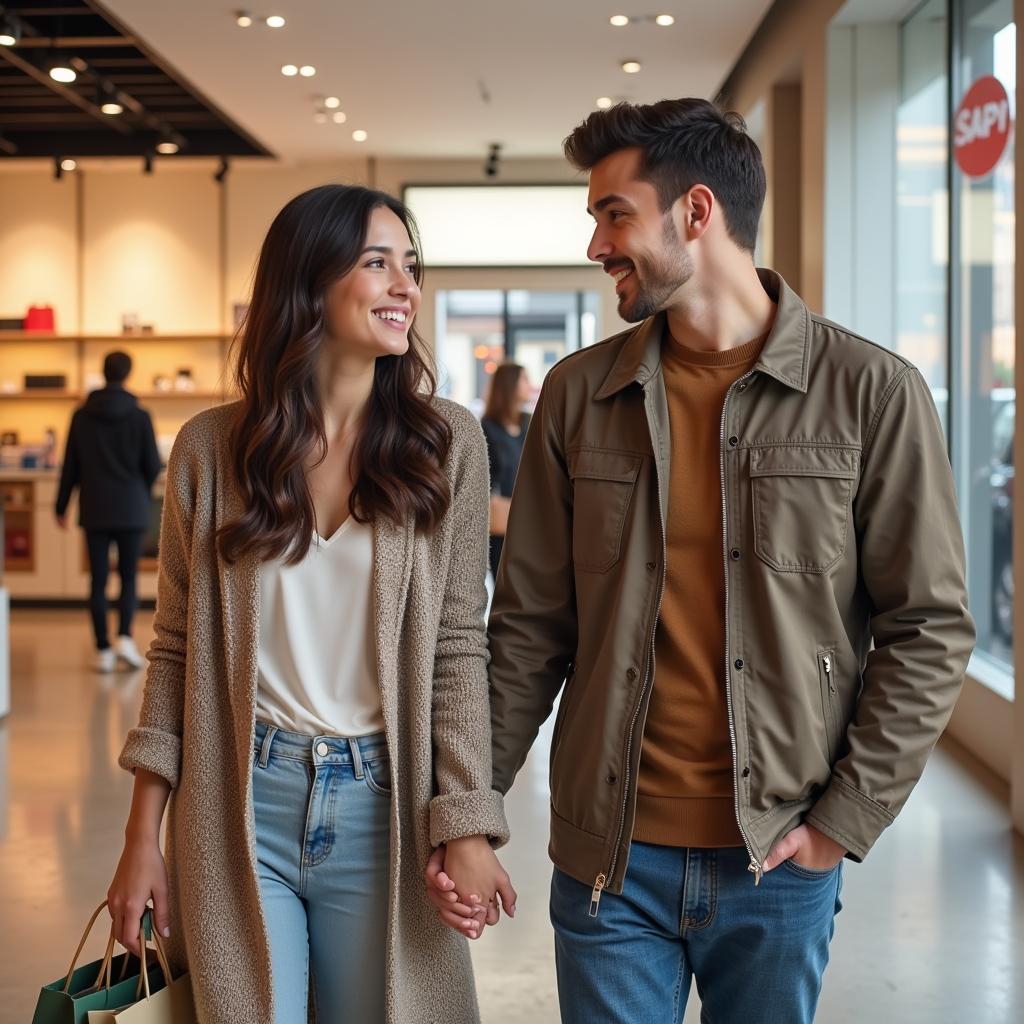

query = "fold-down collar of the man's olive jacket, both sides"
[{"left": 594, "top": 267, "right": 810, "bottom": 398}]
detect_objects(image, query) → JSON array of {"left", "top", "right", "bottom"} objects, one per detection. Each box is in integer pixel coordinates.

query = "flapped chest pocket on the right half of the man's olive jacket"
[{"left": 751, "top": 444, "right": 860, "bottom": 572}]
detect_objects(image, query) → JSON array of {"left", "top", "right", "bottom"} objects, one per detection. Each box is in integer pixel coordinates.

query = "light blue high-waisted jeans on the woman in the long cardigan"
[{"left": 253, "top": 722, "right": 391, "bottom": 1024}]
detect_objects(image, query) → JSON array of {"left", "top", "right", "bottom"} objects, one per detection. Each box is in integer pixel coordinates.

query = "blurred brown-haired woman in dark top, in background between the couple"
[{"left": 480, "top": 362, "right": 530, "bottom": 580}]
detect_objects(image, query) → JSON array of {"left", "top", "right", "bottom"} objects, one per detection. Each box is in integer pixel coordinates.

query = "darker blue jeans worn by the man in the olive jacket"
[{"left": 551, "top": 843, "right": 843, "bottom": 1024}]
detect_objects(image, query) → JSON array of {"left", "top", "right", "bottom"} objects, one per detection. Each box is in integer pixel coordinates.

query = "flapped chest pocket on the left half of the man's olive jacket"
[{"left": 569, "top": 449, "right": 643, "bottom": 572}]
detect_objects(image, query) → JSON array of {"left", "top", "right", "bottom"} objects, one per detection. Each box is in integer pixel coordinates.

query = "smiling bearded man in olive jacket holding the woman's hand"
[{"left": 428, "top": 99, "right": 974, "bottom": 1024}]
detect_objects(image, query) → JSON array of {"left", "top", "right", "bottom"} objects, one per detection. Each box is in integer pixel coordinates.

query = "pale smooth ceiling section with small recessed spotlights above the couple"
[{"left": 90, "top": 0, "right": 771, "bottom": 161}]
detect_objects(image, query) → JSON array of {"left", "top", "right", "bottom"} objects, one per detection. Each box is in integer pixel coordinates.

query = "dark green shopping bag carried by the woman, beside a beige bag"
[{"left": 32, "top": 900, "right": 163, "bottom": 1024}]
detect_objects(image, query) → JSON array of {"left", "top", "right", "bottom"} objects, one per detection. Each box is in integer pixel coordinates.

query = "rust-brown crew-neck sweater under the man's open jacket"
[{"left": 633, "top": 336, "right": 764, "bottom": 847}]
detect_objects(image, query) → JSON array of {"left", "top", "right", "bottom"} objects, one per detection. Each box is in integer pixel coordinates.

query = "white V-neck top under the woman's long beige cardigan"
[{"left": 256, "top": 516, "right": 384, "bottom": 736}]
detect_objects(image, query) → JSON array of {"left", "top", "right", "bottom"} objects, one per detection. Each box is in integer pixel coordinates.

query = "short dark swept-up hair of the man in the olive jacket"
[{"left": 563, "top": 98, "right": 765, "bottom": 253}]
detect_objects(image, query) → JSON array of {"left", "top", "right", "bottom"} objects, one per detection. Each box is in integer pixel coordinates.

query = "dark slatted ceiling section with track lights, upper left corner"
[{"left": 0, "top": 0, "right": 266, "bottom": 159}]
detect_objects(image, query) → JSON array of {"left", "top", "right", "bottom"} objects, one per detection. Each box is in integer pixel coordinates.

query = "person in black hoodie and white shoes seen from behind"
[{"left": 56, "top": 352, "right": 161, "bottom": 672}]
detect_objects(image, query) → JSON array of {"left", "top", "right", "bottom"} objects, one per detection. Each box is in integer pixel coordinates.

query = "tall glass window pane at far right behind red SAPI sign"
[{"left": 951, "top": 0, "right": 1017, "bottom": 673}]
